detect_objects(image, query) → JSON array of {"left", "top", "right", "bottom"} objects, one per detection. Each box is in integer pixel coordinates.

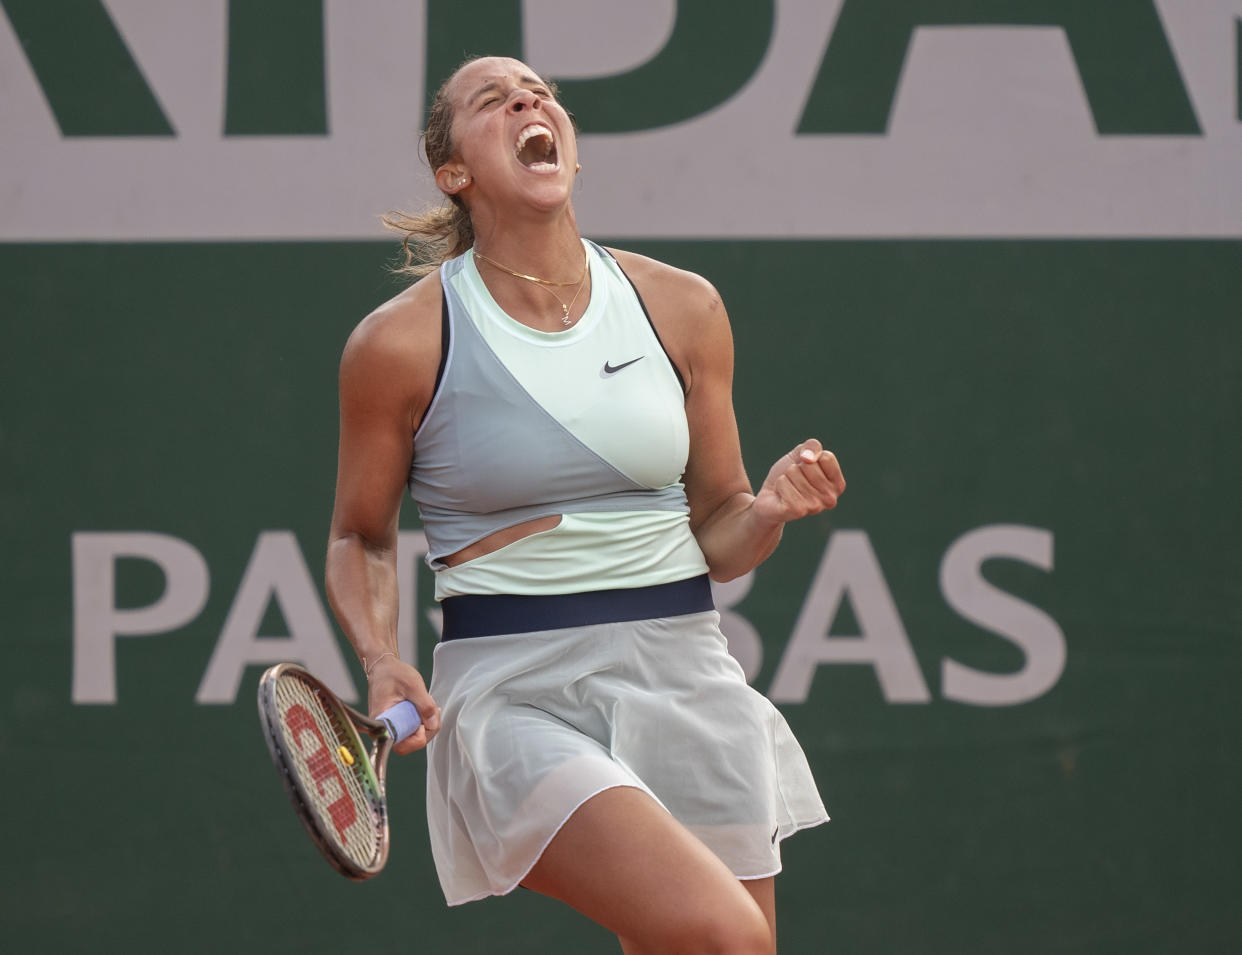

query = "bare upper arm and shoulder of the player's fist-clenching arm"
[{"left": 615, "top": 252, "right": 751, "bottom": 529}]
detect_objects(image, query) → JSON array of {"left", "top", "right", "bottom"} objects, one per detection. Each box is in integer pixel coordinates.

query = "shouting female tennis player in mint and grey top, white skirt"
[{"left": 327, "top": 57, "right": 845, "bottom": 953}]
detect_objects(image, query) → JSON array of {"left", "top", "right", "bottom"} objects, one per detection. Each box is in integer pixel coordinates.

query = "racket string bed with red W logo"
[{"left": 274, "top": 677, "right": 384, "bottom": 867}]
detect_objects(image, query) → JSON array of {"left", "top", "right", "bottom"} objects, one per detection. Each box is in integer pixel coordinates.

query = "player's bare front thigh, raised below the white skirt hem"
[{"left": 522, "top": 787, "right": 774, "bottom": 953}]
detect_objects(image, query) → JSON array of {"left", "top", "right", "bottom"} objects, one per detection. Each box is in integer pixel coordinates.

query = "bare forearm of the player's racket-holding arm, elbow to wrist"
[{"left": 324, "top": 534, "right": 399, "bottom": 666}]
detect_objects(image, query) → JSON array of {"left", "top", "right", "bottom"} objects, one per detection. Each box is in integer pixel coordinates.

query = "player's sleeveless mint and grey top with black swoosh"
[{"left": 409, "top": 241, "right": 707, "bottom": 599}]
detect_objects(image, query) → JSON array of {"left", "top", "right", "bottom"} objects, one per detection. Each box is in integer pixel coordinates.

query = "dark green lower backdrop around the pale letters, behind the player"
[{"left": 0, "top": 237, "right": 1242, "bottom": 955}]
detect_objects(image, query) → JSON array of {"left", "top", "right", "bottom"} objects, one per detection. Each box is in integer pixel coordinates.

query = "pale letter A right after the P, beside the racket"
[{"left": 195, "top": 530, "right": 356, "bottom": 703}]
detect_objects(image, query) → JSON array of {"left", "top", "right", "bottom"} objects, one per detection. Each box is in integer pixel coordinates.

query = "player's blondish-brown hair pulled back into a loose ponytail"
[{"left": 380, "top": 56, "right": 566, "bottom": 278}]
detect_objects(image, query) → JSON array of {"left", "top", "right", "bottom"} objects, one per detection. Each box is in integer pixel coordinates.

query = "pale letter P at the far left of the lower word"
[{"left": 71, "top": 532, "right": 209, "bottom": 703}]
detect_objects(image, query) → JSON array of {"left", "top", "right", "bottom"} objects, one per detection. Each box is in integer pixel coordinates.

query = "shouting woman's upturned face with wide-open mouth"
[{"left": 436, "top": 57, "right": 578, "bottom": 207}]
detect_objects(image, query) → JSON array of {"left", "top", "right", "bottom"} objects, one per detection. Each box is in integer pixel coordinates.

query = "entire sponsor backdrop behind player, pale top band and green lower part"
[{"left": 0, "top": 0, "right": 1242, "bottom": 955}]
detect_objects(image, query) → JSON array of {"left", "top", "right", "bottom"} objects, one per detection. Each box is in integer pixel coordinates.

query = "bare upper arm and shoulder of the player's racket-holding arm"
[{"left": 330, "top": 279, "right": 440, "bottom": 548}]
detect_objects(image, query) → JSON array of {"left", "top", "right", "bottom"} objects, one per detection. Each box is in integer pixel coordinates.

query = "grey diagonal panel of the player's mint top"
[{"left": 409, "top": 249, "right": 688, "bottom": 559}]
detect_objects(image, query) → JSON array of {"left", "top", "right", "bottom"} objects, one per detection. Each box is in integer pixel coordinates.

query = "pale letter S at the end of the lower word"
[{"left": 940, "top": 524, "right": 1066, "bottom": 707}]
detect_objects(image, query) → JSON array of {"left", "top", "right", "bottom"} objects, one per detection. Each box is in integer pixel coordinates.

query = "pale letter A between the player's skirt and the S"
[{"left": 768, "top": 530, "right": 932, "bottom": 703}]
